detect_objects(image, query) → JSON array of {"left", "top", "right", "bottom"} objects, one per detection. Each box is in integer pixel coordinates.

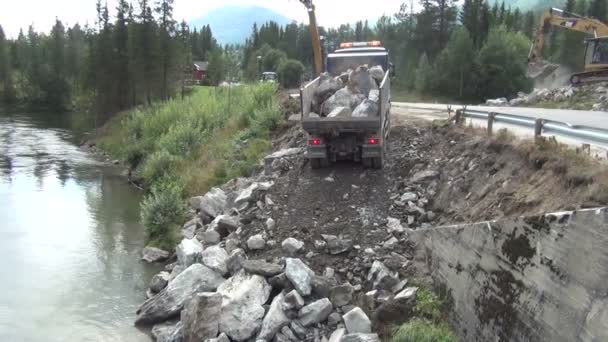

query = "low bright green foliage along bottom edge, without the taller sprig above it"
[{"left": 391, "top": 319, "right": 458, "bottom": 342}]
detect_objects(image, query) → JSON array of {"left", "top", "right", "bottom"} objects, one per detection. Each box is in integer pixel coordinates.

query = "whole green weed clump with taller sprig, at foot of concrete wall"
[{"left": 391, "top": 286, "right": 458, "bottom": 342}]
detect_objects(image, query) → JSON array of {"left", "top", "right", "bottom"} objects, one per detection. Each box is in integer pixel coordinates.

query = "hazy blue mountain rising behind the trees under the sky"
[{"left": 190, "top": 5, "right": 292, "bottom": 45}]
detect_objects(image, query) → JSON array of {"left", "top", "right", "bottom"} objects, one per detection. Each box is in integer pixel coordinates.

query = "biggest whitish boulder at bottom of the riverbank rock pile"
[{"left": 217, "top": 271, "right": 272, "bottom": 341}]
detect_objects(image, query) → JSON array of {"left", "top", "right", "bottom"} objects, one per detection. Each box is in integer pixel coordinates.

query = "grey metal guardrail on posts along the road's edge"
[{"left": 448, "top": 107, "right": 608, "bottom": 148}]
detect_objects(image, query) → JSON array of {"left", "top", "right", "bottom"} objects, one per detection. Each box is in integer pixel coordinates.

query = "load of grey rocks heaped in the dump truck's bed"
[{"left": 309, "top": 64, "right": 384, "bottom": 118}]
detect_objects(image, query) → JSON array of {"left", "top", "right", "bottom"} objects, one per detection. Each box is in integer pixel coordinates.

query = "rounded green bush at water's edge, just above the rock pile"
[{"left": 141, "top": 182, "right": 186, "bottom": 249}]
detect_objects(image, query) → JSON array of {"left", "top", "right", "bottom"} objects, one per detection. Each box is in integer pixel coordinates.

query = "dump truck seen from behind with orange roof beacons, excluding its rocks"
[{"left": 300, "top": 41, "right": 392, "bottom": 169}]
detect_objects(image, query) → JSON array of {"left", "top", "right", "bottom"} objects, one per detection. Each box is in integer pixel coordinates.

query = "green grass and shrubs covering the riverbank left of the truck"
[{"left": 98, "top": 83, "right": 282, "bottom": 248}]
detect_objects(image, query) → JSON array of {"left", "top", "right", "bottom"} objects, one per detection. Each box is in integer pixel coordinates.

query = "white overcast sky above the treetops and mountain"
[{"left": 0, "top": 0, "right": 410, "bottom": 38}]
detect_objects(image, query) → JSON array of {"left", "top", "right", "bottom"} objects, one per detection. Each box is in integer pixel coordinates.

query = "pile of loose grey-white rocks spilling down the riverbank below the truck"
[{"left": 136, "top": 145, "right": 417, "bottom": 342}]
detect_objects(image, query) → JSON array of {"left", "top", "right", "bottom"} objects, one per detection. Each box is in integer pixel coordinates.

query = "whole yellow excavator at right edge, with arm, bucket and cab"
[{"left": 528, "top": 8, "right": 608, "bottom": 85}]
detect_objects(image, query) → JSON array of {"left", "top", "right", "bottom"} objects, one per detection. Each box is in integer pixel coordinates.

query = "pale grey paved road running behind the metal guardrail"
[{"left": 392, "top": 102, "right": 608, "bottom": 130}]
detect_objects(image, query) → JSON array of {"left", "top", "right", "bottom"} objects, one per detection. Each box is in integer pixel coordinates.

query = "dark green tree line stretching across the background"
[{"left": 0, "top": 0, "right": 608, "bottom": 113}]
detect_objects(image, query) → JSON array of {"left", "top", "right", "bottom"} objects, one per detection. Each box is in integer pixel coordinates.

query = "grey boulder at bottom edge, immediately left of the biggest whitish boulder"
[{"left": 181, "top": 292, "right": 222, "bottom": 342}]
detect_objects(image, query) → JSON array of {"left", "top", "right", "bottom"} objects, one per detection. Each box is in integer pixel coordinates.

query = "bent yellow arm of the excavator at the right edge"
[{"left": 528, "top": 8, "right": 608, "bottom": 63}]
